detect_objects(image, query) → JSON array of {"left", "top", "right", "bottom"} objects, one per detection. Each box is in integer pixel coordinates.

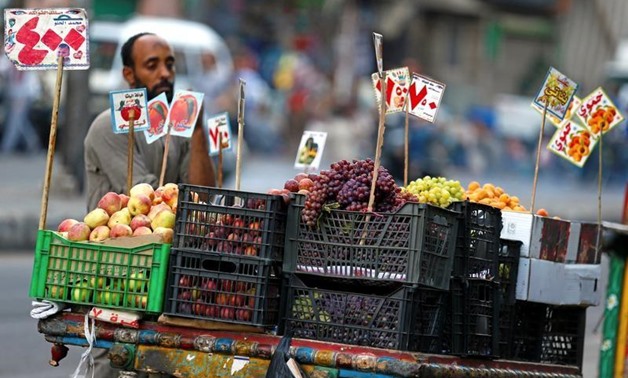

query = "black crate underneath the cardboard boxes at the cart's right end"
[{"left": 504, "top": 301, "right": 586, "bottom": 368}]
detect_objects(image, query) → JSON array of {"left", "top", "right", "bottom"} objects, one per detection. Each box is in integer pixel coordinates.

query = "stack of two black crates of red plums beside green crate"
[{"left": 164, "top": 185, "right": 287, "bottom": 328}]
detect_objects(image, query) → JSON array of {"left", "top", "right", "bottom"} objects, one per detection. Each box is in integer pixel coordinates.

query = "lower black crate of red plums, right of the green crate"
[{"left": 164, "top": 249, "right": 281, "bottom": 327}]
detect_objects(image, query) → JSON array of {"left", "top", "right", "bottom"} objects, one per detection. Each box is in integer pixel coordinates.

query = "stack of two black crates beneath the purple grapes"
[{"left": 280, "top": 195, "right": 458, "bottom": 353}]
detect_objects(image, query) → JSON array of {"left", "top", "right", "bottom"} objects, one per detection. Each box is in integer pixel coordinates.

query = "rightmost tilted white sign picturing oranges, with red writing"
[{"left": 576, "top": 87, "right": 624, "bottom": 139}]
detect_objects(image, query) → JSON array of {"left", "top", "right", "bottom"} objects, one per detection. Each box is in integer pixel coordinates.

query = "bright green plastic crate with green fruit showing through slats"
[{"left": 29, "top": 230, "right": 170, "bottom": 314}]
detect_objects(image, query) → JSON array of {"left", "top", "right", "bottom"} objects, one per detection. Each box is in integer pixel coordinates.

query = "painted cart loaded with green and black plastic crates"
[{"left": 31, "top": 185, "right": 604, "bottom": 377}]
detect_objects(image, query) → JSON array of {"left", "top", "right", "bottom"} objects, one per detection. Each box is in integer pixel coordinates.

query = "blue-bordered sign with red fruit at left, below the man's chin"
[{"left": 109, "top": 88, "right": 149, "bottom": 134}]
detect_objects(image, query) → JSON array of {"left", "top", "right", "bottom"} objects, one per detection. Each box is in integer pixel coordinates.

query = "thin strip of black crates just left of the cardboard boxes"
[{"left": 498, "top": 239, "right": 523, "bottom": 356}]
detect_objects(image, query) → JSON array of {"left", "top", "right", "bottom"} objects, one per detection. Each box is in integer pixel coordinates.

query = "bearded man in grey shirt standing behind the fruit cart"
[{"left": 85, "top": 33, "right": 215, "bottom": 378}]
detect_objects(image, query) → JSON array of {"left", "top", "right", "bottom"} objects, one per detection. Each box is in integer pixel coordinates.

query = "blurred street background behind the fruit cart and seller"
[{"left": 0, "top": 0, "right": 628, "bottom": 378}]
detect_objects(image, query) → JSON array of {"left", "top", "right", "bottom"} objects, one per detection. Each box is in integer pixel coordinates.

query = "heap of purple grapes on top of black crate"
[{"left": 301, "top": 159, "right": 407, "bottom": 226}]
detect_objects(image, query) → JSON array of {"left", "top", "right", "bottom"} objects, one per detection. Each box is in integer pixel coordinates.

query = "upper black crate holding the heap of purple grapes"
[{"left": 284, "top": 196, "right": 458, "bottom": 290}]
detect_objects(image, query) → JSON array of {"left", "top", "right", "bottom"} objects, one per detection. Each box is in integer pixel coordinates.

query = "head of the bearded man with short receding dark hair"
[{"left": 123, "top": 35, "right": 175, "bottom": 101}]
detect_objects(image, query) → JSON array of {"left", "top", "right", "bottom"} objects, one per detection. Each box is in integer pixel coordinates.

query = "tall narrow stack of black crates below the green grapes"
[{"left": 444, "top": 201, "right": 502, "bottom": 358}]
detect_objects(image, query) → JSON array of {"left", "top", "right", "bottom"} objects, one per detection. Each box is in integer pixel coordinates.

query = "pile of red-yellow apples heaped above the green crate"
[{"left": 57, "top": 183, "right": 179, "bottom": 243}]
